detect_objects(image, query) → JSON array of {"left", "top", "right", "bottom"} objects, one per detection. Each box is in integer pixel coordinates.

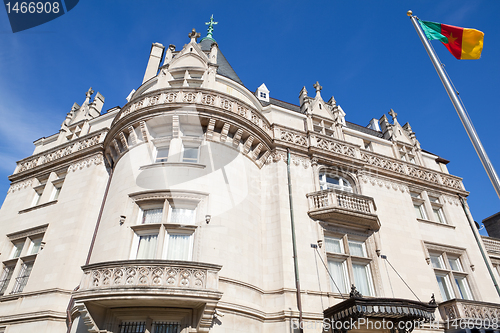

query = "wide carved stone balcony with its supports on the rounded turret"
[{"left": 73, "top": 260, "right": 222, "bottom": 332}]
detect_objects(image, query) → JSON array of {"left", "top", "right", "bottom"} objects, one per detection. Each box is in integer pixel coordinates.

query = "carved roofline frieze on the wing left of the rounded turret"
[{"left": 14, "top": 132, "right": 105, "bottom": 174}]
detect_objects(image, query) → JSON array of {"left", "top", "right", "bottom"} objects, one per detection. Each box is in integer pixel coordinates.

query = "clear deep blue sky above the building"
[{"left": 0, "top": 0, "right": 500, "bottom": 234}]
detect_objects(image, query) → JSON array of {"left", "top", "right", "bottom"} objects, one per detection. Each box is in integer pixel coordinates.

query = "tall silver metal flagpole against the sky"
[{"left": 407, "top": 10, "right": 500, "bottom": 198}]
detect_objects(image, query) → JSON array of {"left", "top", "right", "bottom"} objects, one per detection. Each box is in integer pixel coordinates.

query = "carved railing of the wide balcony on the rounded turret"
[{"left": 80, "top": 260, "right": 221, "bottom": 291}]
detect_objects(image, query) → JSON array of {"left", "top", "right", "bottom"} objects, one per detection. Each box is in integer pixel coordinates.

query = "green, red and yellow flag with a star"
[{"left": 418, "top": 20, "right": 484, "bottom": 60}]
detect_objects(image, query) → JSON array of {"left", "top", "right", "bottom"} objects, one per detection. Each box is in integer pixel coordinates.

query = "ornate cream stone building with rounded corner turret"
[{"left": 0, "top": 23, "right": 500, "bottom": 333}]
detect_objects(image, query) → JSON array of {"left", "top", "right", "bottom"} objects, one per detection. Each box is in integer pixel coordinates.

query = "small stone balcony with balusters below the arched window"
[{"left": 307, "top": 189, "right": 380, "bottom": 230}]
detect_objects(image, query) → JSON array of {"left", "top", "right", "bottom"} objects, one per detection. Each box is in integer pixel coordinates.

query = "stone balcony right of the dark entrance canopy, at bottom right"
[{"left": 439, "top": 299, "right": 500, "bottom": 328}]
